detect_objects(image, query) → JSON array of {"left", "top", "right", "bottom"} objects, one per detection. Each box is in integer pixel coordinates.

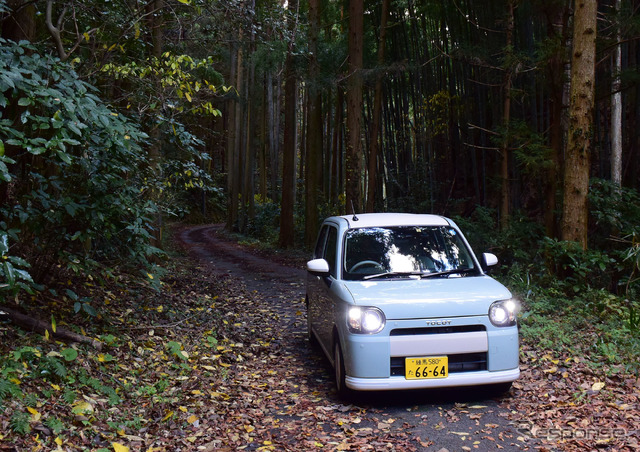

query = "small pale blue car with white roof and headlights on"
[{"left": 306, "top": 213, "right": 520, "bottom": 395}]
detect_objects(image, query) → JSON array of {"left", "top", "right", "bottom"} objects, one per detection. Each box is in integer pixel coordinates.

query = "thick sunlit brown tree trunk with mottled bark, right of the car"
[{"left": 562, "top": 0, "right": 598, "bottom": 249}]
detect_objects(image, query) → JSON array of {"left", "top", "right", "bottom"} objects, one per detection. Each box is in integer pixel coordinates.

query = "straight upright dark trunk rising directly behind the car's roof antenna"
[{"left": 345, "top": 0, "right": 364, "bottom": 213}]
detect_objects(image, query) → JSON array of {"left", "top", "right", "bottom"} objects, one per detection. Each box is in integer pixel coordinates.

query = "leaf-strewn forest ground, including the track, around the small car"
[{"left": 0, "top": 226, "right": 640, "bottom": 452}]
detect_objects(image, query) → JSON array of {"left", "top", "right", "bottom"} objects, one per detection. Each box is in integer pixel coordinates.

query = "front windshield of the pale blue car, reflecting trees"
[{"left": 343, "top": 226, "right": 477, "bottom": 280}]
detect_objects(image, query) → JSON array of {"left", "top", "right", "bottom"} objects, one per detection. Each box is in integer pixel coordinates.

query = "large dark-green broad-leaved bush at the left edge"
[{"left": 0, "top": 41, "right": 158, "bottom": 298}]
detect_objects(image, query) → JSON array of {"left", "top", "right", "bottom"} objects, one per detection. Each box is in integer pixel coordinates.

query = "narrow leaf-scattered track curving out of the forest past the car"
[{"left": 178, "top": 226, "right": 534, "bottom": 451}]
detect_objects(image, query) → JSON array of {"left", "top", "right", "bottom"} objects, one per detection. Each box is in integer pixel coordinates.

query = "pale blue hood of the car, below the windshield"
[{"left": 344, "top": 276, "right": 511, "bottom": 320}]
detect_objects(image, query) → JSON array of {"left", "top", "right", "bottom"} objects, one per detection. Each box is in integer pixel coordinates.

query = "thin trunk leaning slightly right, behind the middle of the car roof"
[{"left": 366, "top": 0, "right": 389, "bottom": 212}]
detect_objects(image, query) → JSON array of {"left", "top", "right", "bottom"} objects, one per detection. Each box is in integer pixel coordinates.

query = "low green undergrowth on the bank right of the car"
[{"left": 455, "top": 200, "right": 640, "bottom": 372}]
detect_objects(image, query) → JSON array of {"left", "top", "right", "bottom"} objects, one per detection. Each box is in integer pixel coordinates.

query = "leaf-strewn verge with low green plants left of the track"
[{"left": 0, "top": 247, "right": 233, "bottom": 452}]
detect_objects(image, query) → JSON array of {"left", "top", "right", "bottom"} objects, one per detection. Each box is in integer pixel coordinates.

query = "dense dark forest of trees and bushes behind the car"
[{"left": 0, "top": 0, "right": 640, "bottom": 312}]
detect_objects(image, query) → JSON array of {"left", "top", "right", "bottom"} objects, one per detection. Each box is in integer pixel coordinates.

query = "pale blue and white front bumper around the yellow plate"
[{"left": 341, "top": 317, "right": 520, "bottom": 391}]
